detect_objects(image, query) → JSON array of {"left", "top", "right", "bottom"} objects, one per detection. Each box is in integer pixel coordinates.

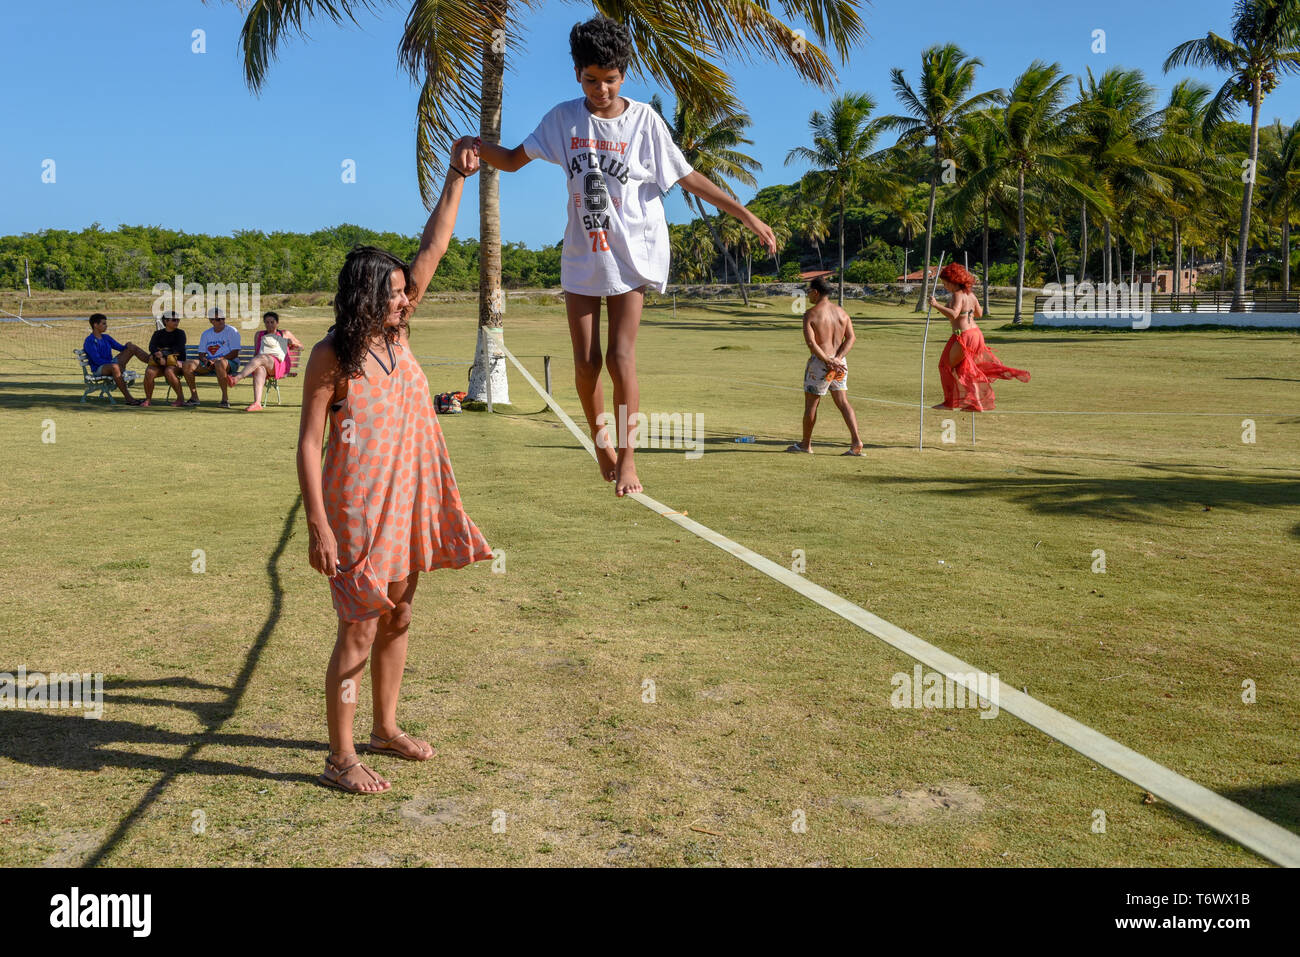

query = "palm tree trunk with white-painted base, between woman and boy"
[{"left": 467, "top": 0, "right": 510, "bottom": 404}]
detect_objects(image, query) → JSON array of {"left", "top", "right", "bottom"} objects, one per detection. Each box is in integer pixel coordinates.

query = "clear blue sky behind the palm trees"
[{"left": 0, "top": 0, "right": 1300, "bottom": 246}]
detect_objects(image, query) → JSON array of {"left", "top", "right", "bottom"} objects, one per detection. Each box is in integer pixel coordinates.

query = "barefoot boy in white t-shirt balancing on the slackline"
[{"left": 475, "top": 17, "right": 776, "bottom": 497}]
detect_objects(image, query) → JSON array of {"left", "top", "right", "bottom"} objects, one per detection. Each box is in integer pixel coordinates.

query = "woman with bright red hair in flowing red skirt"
[{"left": 930, "top": 263, "right": 1030, "bottom": 412}]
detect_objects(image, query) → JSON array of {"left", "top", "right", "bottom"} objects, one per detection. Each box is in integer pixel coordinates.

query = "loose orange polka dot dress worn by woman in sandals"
[{"left": 321, "top": 341, "right": 491, "bottom": 622}]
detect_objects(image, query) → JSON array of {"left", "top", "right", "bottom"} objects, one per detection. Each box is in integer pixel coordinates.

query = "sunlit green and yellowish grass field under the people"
[{"left": 0, "top": 302, "right": 1300, "bottom": 866}]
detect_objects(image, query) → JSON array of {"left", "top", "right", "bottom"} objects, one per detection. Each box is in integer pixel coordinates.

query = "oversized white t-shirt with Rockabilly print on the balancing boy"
[{"left": 524, "top": 98, "right": 692, "bottom": 295}]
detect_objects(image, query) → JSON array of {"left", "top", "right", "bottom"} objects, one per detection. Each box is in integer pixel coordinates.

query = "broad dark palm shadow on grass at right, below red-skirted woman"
[{"left": 865, "top": 465, "right": 1300, "bottom": 519}]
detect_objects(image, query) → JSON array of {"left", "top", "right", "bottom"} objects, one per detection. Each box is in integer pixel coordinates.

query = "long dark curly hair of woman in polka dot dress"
[{"left": 330, "top": 246, "right": 411, "bottom": 378}]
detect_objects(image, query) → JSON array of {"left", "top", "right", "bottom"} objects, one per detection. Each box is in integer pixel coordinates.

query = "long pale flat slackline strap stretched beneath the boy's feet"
[{"left": 502, "top": 346, "right": 1300, "bottom": 867}]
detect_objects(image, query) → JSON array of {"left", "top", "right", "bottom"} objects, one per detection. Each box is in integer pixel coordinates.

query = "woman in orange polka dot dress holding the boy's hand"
[{"left": 298, "top": 138, "right": 491, "bottom": 794}]
